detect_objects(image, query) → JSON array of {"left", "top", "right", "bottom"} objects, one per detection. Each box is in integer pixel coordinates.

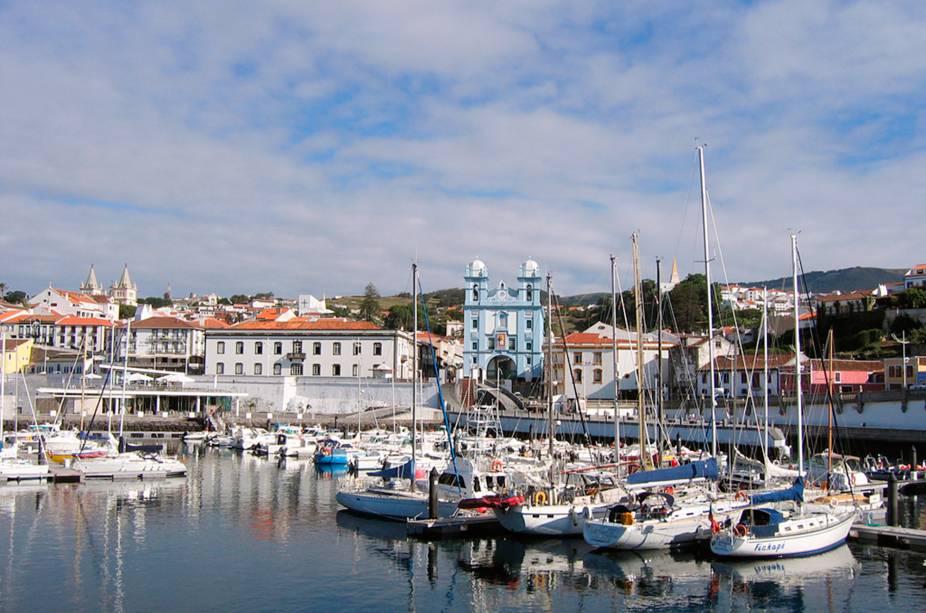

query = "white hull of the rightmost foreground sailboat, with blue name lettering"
[{"left": 711, "top": 512, "right": 855, "bottom": 558}]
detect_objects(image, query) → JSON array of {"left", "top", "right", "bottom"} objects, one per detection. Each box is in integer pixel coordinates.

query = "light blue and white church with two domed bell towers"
[{"left": 463, "top": 259, "right": 544, "bottom": 381}]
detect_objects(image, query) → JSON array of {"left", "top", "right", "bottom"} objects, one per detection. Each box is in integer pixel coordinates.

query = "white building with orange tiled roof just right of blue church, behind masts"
[{"left": 553, "top": 322, "right": 678, "bottom": 400}]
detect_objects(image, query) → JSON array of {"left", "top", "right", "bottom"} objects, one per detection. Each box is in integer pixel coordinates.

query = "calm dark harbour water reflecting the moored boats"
[{"left": 0, "top": 449, "right": 926, "bottom": 612}]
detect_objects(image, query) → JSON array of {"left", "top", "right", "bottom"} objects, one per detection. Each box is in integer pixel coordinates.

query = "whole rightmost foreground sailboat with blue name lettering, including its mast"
[{"left": 711, "top": 234, "right": 856, "bottom": 558}]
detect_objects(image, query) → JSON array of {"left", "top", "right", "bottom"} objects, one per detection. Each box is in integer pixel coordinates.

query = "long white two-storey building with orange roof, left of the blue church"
[{"left": 205, "top": 317, "right": 413, "bottom": 379}]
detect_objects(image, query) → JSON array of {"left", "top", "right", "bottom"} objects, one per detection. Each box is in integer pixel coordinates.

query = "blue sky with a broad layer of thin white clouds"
[{"left": 0, "top": 0, "right": 926, "bottom": 296}]
